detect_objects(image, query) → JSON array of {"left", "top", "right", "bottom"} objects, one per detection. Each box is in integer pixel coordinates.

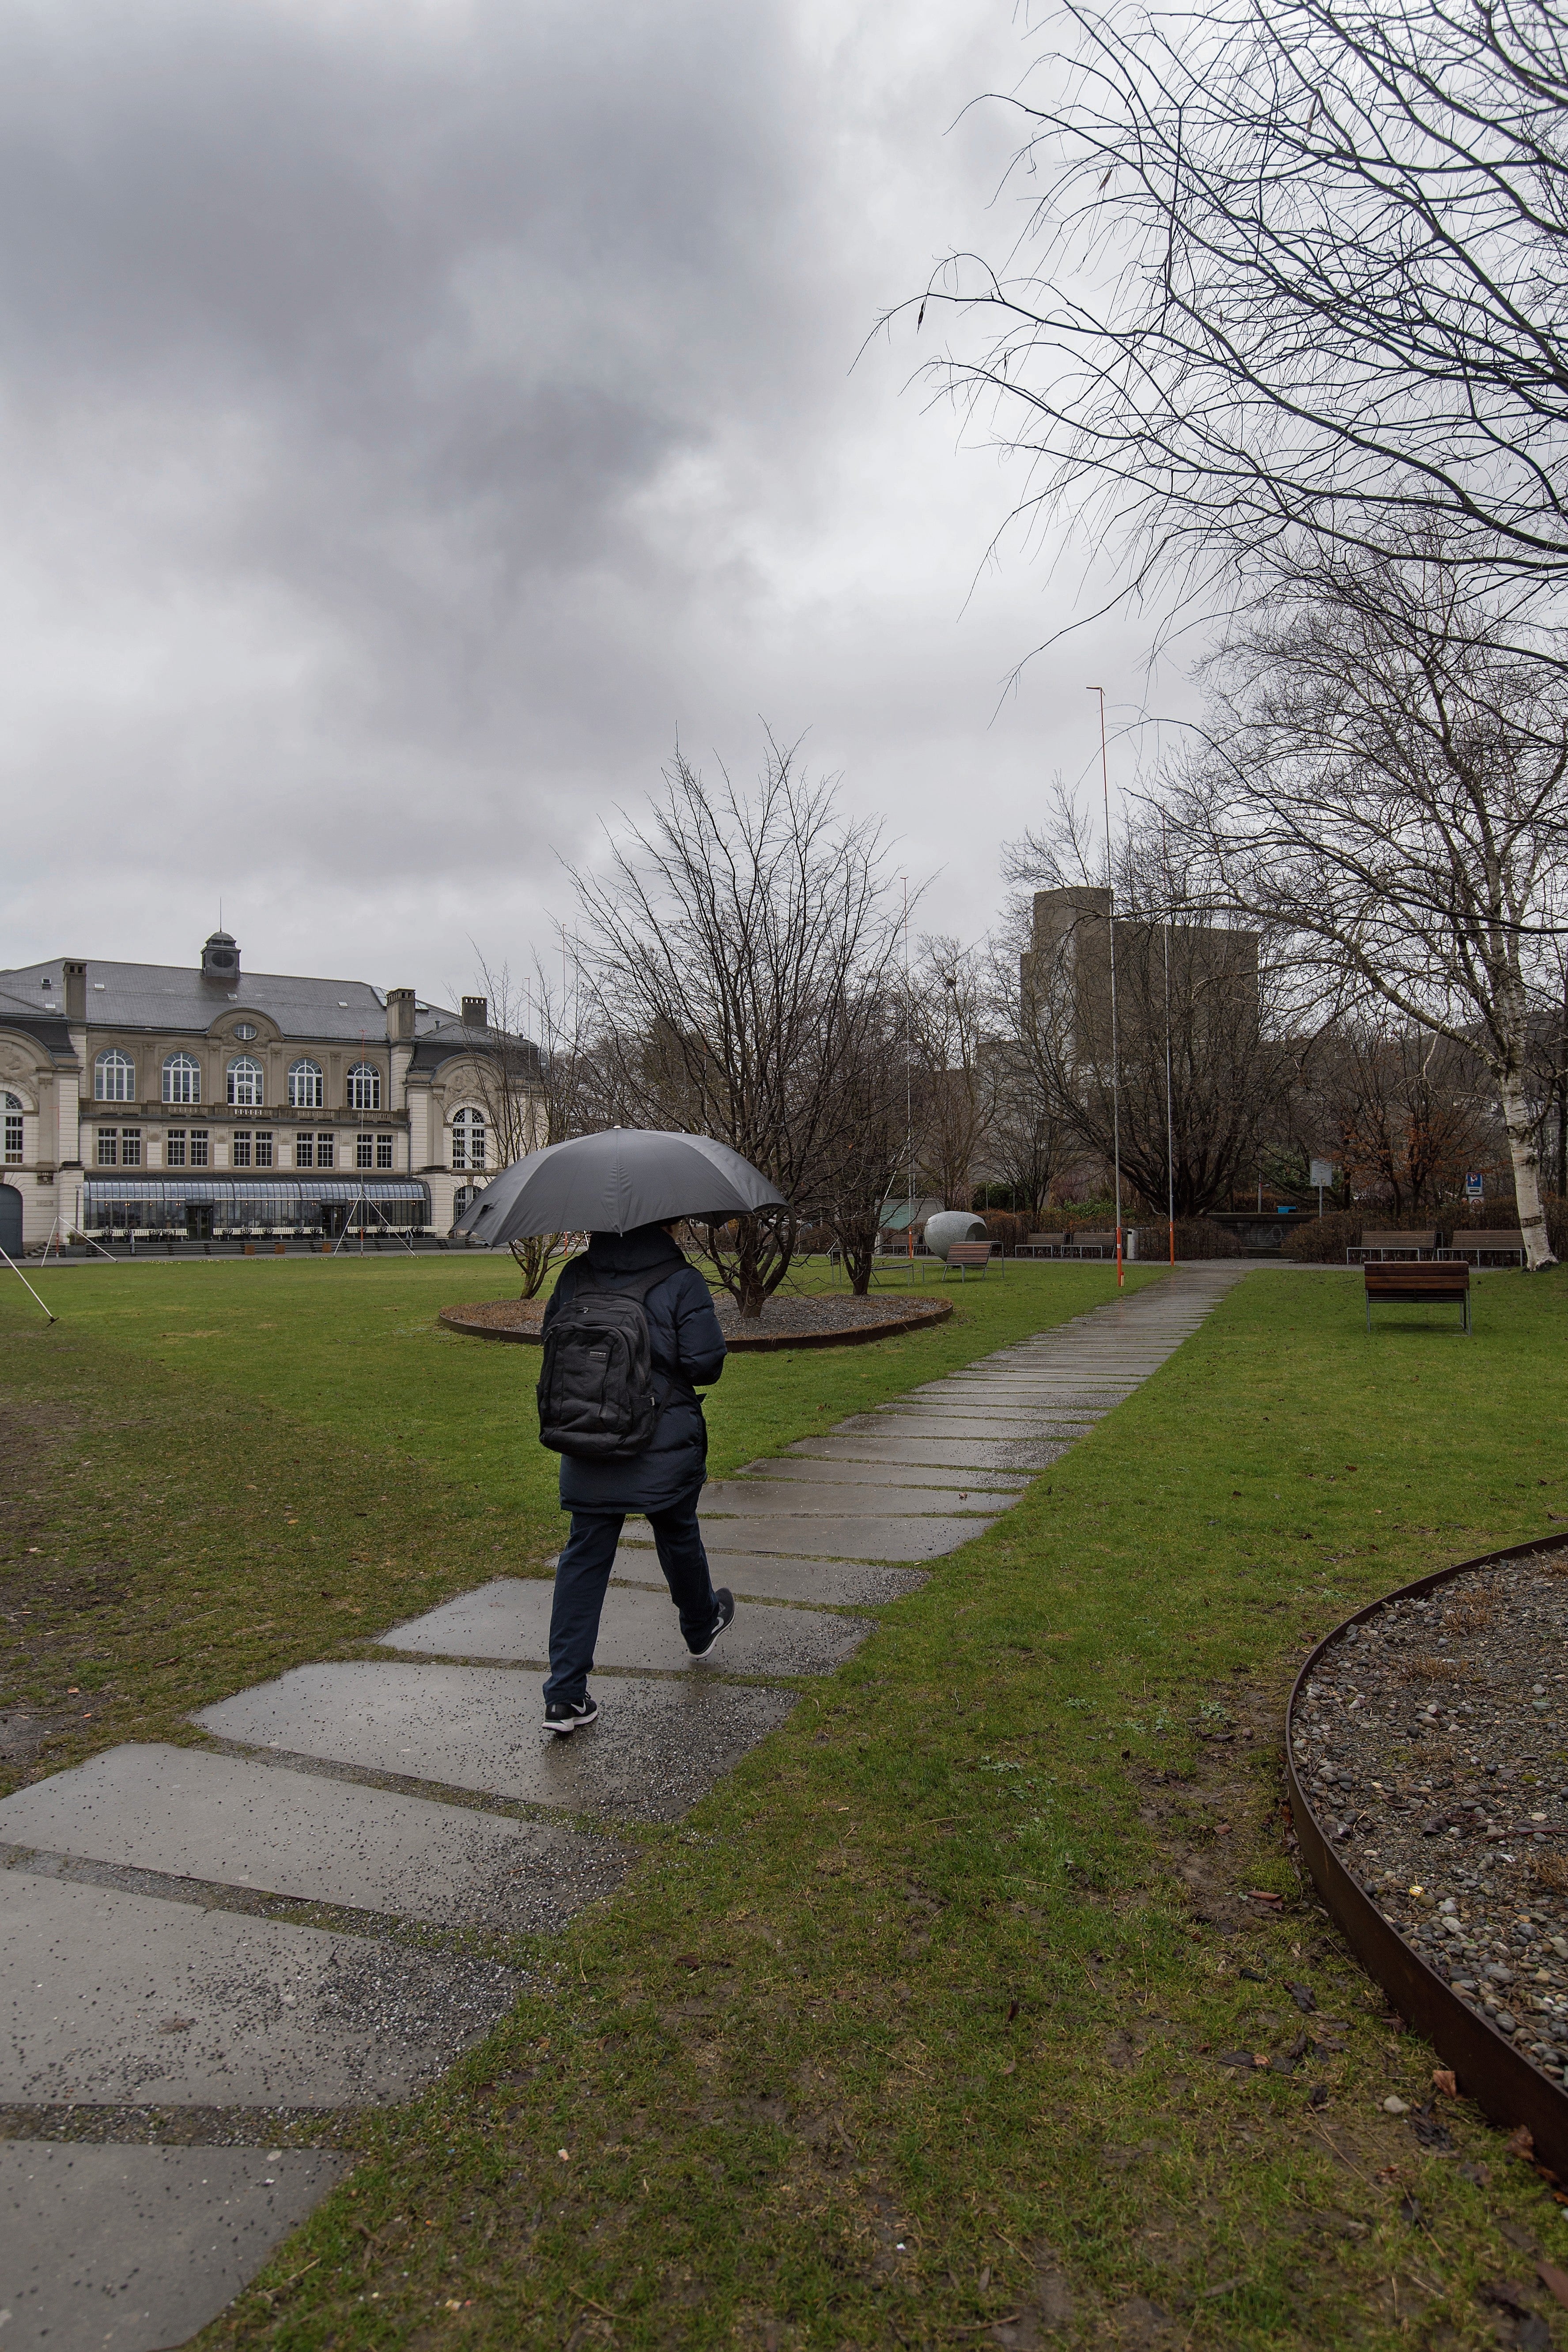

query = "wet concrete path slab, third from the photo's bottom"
[{"left": 0, "top": 1745, "right": 630, "bottom": 1933}]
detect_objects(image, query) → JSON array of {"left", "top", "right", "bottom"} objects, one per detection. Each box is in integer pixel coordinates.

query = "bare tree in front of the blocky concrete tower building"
[{"left": 1006, "top": 793, "right": 1295, "bottom": 1216}]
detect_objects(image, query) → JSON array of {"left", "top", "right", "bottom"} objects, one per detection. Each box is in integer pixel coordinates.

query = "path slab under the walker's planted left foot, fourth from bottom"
[{"left": 200, "top": 1658, "right": 794, "bottom": 1816}]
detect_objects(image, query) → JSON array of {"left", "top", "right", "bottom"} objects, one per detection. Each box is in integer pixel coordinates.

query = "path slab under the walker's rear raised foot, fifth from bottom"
[{"left": 381, "top": 1580, "right": 869, "bottom": 1675}]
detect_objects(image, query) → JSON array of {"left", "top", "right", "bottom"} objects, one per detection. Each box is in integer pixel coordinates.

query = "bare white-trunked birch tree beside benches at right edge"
[{"left": 1164, "top": 544, "right": 1568, "bottom": 1265}]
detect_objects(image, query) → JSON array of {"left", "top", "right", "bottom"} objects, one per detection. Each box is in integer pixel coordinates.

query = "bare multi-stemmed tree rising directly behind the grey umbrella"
[{"left": 574, "top": 739, "right": 898, "bottom": 1315}]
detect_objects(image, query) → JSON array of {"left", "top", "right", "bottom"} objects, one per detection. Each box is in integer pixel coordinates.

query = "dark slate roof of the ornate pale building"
[{"left": 0, "top": 957, "right": 461, "bottom": 1044}]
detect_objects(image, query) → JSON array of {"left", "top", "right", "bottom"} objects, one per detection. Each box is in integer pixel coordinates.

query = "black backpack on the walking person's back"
[{"left": 538, "top": 1261, "right": 677, "bottom": 1463}]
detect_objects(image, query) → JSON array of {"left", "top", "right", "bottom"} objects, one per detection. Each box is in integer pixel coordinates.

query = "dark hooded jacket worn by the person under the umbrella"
[{"left": 543, "top": 1225, "right": 724, "bottom": 1512}]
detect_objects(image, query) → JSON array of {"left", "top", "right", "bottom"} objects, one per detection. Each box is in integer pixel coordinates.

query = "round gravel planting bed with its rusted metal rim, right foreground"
[{"left": 1286, "top": 1543, "right": 1568, "bottom": 2175}]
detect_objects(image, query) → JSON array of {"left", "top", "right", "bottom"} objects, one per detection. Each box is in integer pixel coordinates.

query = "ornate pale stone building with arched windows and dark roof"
[{"left": 0, "top": 931, "right": 538, "bottom": 1256}]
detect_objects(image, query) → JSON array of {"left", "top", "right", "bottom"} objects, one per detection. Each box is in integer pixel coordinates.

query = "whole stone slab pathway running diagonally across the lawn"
[{"left": 0, "top": 1265, "right": 1246, "bottom": 2352}]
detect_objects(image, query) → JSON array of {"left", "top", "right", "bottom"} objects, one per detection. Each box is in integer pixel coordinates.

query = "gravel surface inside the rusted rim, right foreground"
[{"left": 1291, "top": 1552, "right": 1568, "bottom": 2081}]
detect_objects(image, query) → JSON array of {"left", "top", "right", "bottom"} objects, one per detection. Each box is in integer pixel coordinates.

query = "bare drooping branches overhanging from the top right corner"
[{"left": 919, "top": 0, "right": 1568, "bottom": 616}]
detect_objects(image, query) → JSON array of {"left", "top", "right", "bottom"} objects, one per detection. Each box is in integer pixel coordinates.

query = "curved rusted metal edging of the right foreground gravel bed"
[{"left": 1286, "top": 1536, "right": 1568, "bottom": 2180}]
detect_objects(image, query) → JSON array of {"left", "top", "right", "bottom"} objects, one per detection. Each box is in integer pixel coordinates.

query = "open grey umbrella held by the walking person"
[{"left": 454, "top": 1127, "right": 783, "bottom": 1242}]
